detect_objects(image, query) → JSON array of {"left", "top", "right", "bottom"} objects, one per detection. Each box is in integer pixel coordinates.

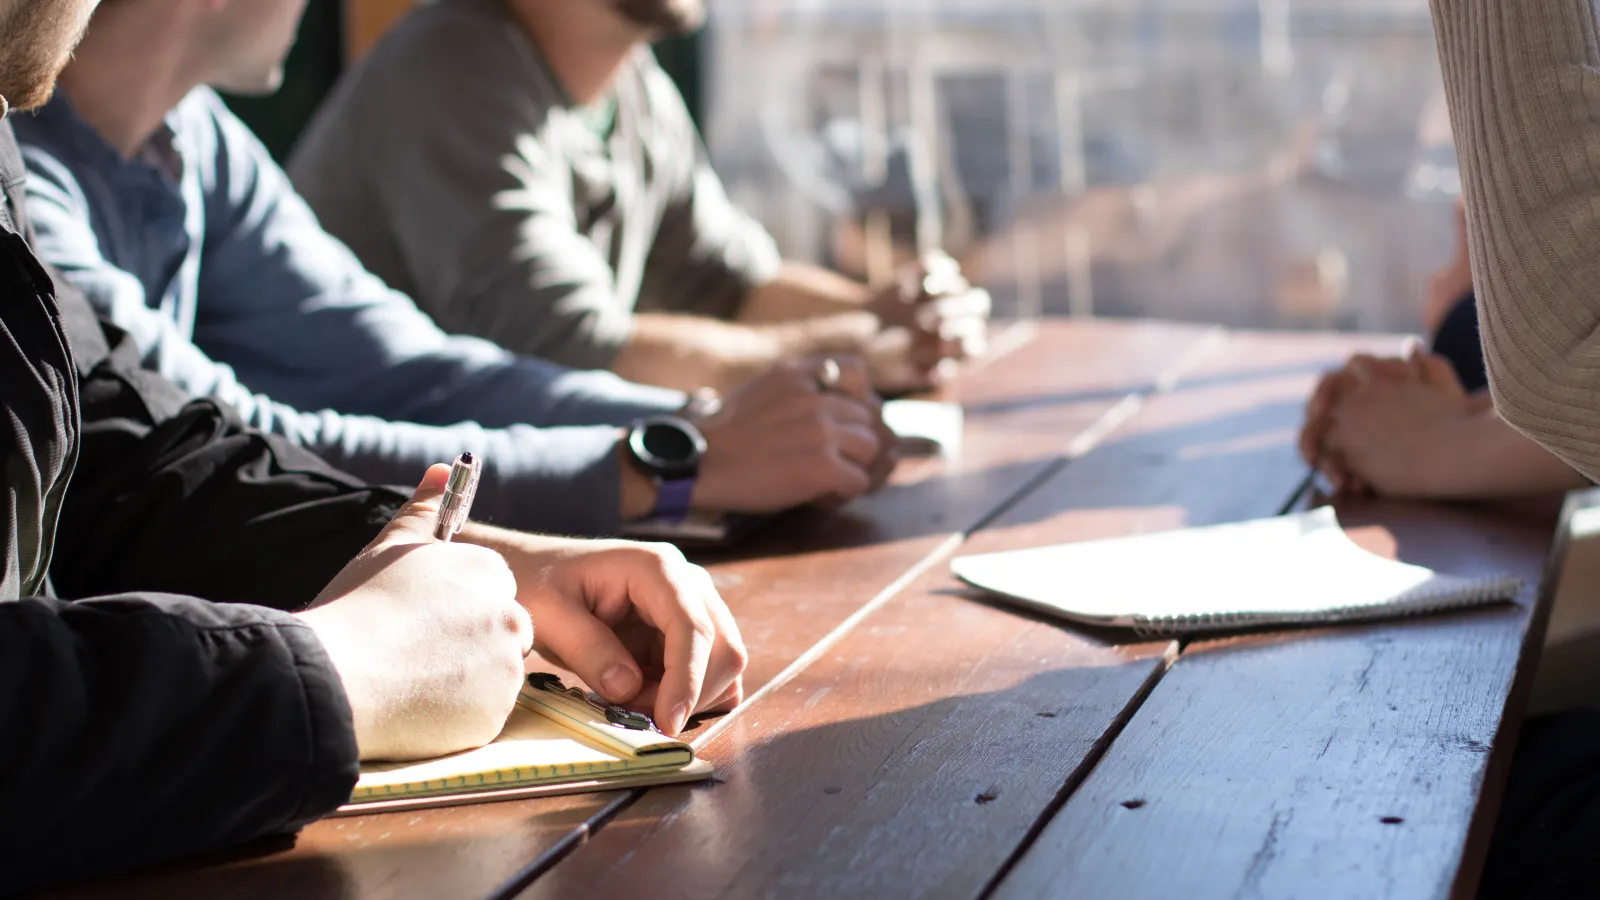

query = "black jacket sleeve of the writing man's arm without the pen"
[{"left": 51, "top": 279, "right": 409, "bottom": 610}]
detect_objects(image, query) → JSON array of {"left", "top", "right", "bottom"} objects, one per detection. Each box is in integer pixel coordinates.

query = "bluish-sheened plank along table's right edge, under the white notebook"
[{"left": 995, "top": 493, "right": 1554, "bottom": 900}]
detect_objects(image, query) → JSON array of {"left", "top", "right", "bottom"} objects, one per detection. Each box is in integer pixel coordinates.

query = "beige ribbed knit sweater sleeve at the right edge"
[{"left": 1432, "top": 0, "right": 1600, "bottom": 479}]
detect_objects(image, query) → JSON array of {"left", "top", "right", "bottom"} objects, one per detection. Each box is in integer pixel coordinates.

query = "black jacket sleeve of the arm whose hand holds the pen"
[{"left": 0, "top": 594, "right": 357, "bottom": 895}]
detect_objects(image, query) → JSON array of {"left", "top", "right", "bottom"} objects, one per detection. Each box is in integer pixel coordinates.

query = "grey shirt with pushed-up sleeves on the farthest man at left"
[{"left": 291, "top": 19, "right": 781, "bottom": 368}]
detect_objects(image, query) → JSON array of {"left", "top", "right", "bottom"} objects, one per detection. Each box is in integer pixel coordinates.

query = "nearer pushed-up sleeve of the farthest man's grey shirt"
[{"left": 290, "top": 21, "right": 632, "bottom": 370}]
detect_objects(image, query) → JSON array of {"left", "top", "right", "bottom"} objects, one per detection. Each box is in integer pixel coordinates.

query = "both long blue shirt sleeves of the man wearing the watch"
[{"left": 17, "top": 102, "right": 683, "bottom": 535}]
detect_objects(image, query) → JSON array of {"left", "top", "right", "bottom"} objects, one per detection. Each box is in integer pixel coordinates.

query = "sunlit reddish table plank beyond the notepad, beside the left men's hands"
[{"left": 681, "top": 322, "right": 1213, "bottom": 693}]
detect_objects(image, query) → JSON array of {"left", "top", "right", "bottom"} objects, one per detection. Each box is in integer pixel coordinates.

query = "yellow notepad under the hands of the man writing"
[{"left": 339, "top": 676, "right": 712, "bottom": 815}]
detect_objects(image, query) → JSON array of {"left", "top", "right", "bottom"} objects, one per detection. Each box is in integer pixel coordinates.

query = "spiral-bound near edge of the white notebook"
[{"left": 1133, "top": 575, "right": 1522, "bottom": 637}]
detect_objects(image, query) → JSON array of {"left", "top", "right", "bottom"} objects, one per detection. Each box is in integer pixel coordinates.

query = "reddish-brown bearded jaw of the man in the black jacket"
[{"left": 0, "top": 0, "right": 94, "bottom": 109}]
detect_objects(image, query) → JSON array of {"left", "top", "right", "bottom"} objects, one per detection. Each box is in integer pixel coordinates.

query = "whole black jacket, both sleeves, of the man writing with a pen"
[{"left": 0, "top": 122, "right": 366, "bottom": 894}]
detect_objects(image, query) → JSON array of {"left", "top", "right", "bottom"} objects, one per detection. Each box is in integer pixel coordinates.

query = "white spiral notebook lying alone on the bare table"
[{"left": 950, "top": 506, "right": 1522, "bottom": 636}]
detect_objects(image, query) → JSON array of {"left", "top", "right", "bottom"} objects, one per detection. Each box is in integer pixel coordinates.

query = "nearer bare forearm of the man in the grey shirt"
[{"left": 611, "top": 309, "right": 877, "bottom": 391}]
